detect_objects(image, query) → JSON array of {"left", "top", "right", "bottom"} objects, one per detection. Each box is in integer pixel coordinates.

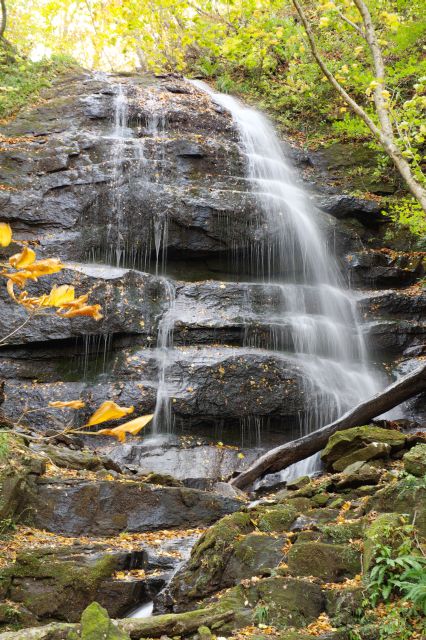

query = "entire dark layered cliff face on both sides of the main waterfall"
[{"left": 0, "top": 74, "right": 426, "bottom": 456}]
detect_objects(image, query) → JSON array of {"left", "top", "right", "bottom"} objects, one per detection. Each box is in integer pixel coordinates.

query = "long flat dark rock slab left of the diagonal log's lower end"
[{"left": 33, "top": 480, "right": 241, "bottom": 536}]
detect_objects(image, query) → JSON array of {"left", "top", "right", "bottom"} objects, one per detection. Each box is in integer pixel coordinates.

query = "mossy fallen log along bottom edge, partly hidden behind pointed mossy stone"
[{"left": 0, "top": 608, "right": 234, "bottom": 640}]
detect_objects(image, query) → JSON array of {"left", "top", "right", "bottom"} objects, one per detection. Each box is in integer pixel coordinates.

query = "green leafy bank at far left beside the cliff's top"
[{"left": 0, "top": 56, "right": 75, "bottom": 118}]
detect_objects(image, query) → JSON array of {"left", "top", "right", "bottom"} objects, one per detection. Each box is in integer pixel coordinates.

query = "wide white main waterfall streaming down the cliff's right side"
[{"left": 192, "top": 81, "right": 379, "bottom": 450}]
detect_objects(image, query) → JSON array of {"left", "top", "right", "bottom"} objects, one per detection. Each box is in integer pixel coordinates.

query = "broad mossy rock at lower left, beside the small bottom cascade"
[{"left": 0, "top": 545, "right": 145, "bottom": 622}]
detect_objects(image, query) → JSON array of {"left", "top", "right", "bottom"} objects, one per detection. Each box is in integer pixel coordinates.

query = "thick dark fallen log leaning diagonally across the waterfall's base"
[{"left": 230, "top": 364, "right": 426, "bottom": 489}]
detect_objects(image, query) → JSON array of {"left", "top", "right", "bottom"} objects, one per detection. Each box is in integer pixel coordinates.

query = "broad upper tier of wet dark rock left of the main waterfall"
[{"left": 1, "top": 74, "right": 257, "bottom": 266}]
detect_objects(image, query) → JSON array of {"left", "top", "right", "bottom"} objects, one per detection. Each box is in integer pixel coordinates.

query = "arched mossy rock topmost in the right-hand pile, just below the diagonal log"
[{"left": 321, "top": 425, "right": 406, "bottom": 468}]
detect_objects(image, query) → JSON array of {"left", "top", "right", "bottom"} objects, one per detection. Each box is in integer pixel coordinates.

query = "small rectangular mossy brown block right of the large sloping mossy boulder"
[{"left": 288, "top": 542, "right": 361, "bottom": 582}]
